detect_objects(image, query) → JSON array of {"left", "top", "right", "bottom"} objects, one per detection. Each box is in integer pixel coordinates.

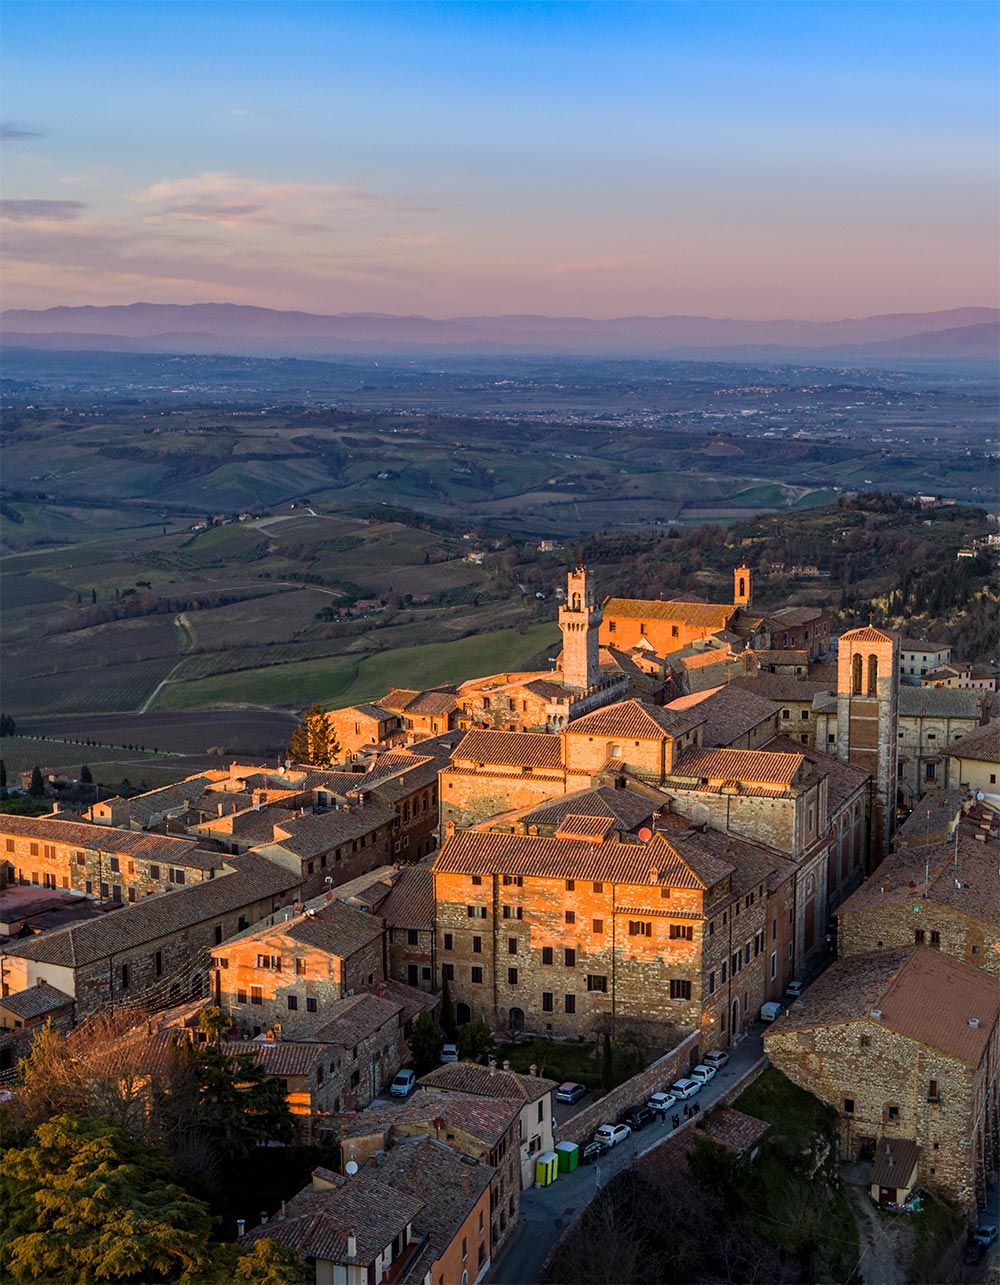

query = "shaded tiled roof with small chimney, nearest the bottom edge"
[{"left": 242, "top": 1168, "right": 424, "bottom": 1267}]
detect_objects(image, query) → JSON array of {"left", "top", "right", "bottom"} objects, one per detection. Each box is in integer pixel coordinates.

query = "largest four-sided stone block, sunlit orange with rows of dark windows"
[{"left": 433, "top": 815, "right": 793, "bottom": 1047}]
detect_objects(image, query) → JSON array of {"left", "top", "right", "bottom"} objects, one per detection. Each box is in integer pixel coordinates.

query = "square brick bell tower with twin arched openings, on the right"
[{"left": 837, "top": 625, "right": 900, "bottom": 866}]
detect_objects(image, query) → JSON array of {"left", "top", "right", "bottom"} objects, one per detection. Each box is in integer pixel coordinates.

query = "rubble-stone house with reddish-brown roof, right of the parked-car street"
[{"left": 765, "top": 946, "right": 1000, "bottom": 1210}]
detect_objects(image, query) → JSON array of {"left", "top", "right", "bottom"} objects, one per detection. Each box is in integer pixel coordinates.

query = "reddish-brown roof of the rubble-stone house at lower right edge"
[{"left": 772, "top": 946, "right": 1000, "bottom": 1065}]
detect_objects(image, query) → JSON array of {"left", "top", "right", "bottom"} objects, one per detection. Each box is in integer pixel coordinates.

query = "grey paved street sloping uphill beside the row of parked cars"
[{"left": 488, "top": 1024, "right": 763, "bottom": 1285}]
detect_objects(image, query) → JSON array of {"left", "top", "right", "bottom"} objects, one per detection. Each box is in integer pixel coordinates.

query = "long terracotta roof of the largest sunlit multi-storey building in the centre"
[{"left": 434, "top": 830, "right": 731, "bottom": 888}]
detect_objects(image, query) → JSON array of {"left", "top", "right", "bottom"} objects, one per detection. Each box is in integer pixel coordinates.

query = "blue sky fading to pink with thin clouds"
[{"left": 0, "top": 0, "right": 1000, "bottom": 319}]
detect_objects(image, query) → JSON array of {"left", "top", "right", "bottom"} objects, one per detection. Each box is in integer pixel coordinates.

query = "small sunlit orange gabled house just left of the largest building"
[{"left": 210, "top": 901, "right": 386, "bottom": 1034}]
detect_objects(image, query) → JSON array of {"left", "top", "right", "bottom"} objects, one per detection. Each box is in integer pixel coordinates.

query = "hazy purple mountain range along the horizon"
[{"left": 0, "top": 303, "right": 1000, "bottom": 360}]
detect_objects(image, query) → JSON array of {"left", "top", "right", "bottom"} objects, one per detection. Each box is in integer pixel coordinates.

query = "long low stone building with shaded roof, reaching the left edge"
[{"left": 0, "top": 852, "right": 301, "bottom": 1018}]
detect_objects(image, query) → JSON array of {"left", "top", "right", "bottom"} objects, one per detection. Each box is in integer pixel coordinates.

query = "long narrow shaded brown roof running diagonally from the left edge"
[{"left": 5, "top": 852, "right": 301, "bottom": 968}]
